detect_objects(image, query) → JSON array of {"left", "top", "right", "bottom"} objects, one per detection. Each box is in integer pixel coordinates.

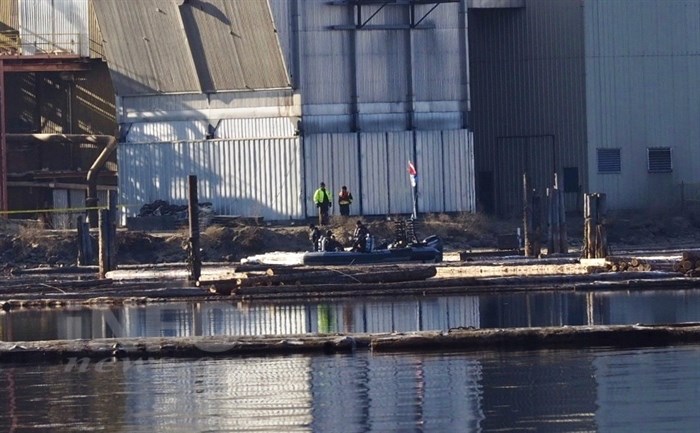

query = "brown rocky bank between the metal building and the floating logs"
[{"left": 0, "top": 208, "right": 700, "bottom": 270}]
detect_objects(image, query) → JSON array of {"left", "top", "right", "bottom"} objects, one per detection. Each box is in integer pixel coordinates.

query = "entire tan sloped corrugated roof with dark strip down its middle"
[{"left": 93, "top": 0, "right": 289, "bottom": 95}]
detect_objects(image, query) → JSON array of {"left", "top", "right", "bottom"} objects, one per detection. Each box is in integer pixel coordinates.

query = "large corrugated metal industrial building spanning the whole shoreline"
[{"left": 0, "top": 0, "right": 700, "bottom": 220}]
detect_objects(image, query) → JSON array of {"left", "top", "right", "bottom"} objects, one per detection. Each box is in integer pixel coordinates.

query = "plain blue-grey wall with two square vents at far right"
[{"left": 584, "top": 0, "right": 700, "bottom": 209}]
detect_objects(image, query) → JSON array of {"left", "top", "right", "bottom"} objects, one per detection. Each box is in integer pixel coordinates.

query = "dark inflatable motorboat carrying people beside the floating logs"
[{"left": 302, "top": 236, "right": 442, "bottom": 265}]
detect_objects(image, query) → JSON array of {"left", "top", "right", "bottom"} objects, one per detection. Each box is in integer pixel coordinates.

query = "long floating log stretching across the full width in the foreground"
[{"left": 6, "top": 323, "right": 700, "bottom": 362}]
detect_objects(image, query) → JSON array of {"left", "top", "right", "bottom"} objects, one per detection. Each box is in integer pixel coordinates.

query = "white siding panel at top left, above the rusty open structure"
[{"left": 19, "top": 0, "right": 90, "bottom": 57}]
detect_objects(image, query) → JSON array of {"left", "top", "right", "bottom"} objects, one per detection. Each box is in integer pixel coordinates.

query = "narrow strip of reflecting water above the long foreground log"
[{"left": 0, "top": 290, "right": 700, "bottom": 341}]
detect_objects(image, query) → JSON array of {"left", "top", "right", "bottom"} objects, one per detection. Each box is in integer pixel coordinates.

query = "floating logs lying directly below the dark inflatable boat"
[{"left": 197, "top": 265, "right": 437, "bottom": 295}]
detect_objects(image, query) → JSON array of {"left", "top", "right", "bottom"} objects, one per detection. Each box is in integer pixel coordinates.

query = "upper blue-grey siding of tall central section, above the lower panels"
[{"left": 292, "top": 0, "right": 469, "bottom": 134}]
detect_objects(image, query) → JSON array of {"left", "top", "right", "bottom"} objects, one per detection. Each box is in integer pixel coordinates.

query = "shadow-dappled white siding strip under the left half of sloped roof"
[{"left": 126, "top": 120, "right": 209, "bottom": 143}]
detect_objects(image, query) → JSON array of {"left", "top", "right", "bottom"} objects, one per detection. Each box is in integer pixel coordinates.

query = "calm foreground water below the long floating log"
[{"left": 0, "top": 346, "right": 700, "bottom": 433}]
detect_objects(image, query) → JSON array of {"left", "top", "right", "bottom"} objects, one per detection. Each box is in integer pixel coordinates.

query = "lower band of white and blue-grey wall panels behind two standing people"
[{"left": 118, "top": 130, "right": 475, "bottom": 220}]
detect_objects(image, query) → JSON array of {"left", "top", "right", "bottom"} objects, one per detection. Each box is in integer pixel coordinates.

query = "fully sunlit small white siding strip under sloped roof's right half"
[{"left": 215, "top": 117, "right": 297, "bottom": 139}]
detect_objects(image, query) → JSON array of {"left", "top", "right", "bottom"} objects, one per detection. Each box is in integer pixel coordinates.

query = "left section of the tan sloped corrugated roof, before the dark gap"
[{"left": 93, "top": 0, "right": 200, "bottom": 96}]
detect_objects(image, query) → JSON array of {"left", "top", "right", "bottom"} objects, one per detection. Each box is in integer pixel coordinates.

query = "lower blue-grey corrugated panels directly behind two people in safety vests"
[{"left": 304, "top": 130, "right": 476, "bottom": 216}]
